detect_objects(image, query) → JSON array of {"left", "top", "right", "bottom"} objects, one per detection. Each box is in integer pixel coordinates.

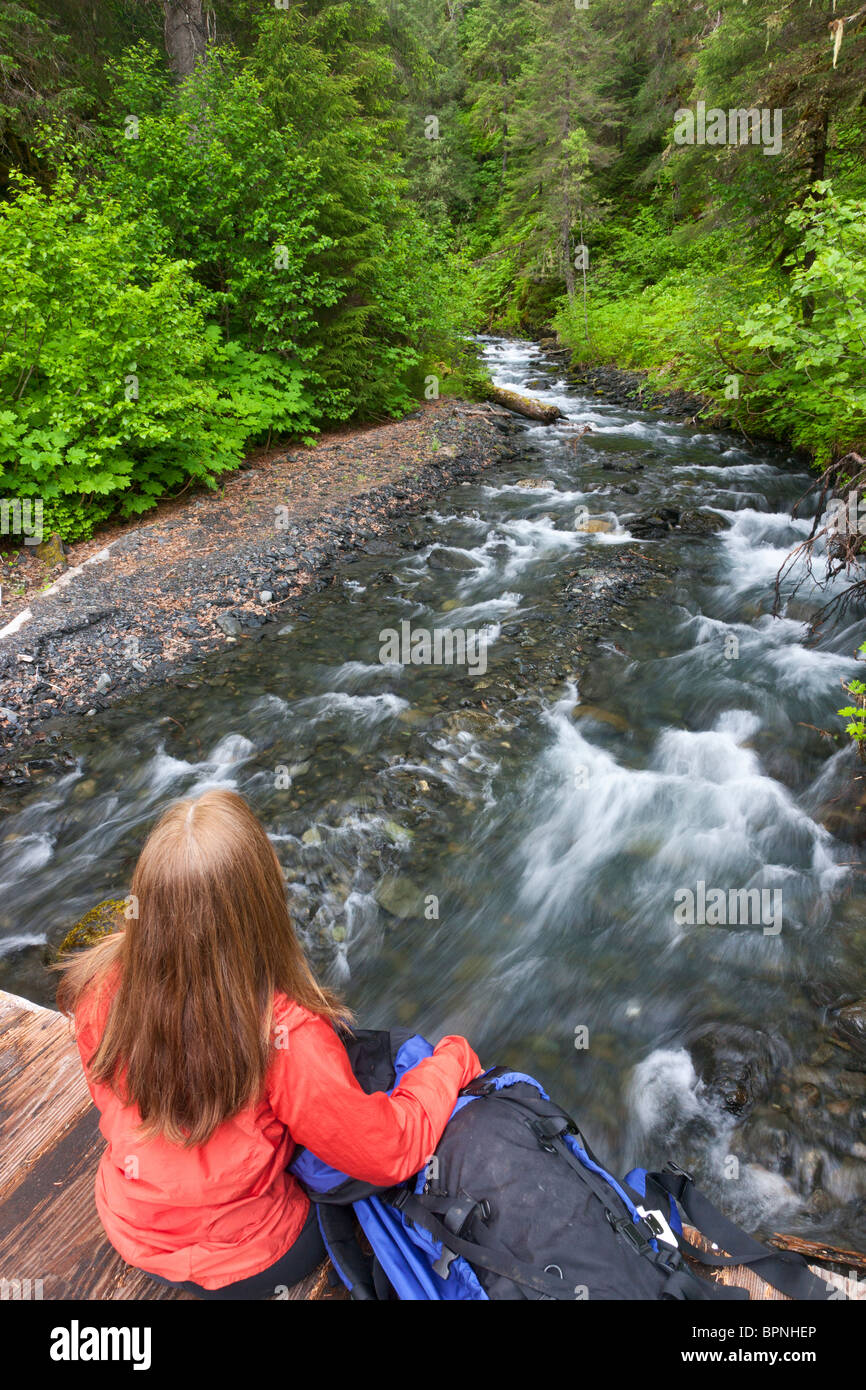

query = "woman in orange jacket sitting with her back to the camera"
[{"left": 57, "top": 791, "right": 481, "bottom": 1298}]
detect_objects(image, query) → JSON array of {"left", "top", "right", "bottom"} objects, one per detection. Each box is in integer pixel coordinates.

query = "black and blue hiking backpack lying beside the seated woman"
[{"left": 289, "top": 1029, "right": 831, "bottom": 1301}]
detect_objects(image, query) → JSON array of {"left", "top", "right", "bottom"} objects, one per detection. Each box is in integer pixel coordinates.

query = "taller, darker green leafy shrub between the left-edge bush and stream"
[{"left": 101, "top": 43, "right": 480, "bottom": 420}]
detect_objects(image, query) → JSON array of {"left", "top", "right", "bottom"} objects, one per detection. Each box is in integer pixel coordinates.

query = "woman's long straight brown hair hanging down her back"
[{"left": 57, "top": 790, "right": 352, "bottom": 1145}]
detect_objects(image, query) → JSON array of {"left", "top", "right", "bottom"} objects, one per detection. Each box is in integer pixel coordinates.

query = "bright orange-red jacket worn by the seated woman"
[{"left": 75, "top": 988, "right": 481, "bottom": 1289}]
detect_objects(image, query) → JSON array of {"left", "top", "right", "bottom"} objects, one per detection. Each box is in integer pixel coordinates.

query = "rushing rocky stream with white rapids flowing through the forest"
[{"left": 0, "top": 339, "right": 866, "bottom": 1243}]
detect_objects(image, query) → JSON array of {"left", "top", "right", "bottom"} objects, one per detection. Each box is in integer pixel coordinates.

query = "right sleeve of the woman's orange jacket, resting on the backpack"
[{"left": 268, "top": 1012, "right": 482, "bottom": 1186}]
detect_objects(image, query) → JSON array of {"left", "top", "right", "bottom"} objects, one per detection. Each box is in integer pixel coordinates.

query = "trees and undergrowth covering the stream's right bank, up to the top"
[{"left": 458, "top": 0, "right": 866, "bottom": 463}]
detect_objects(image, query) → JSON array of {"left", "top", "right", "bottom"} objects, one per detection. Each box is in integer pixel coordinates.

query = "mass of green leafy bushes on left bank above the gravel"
[{"left": 0, "top": 3, "right": 477, "bottom": 538}]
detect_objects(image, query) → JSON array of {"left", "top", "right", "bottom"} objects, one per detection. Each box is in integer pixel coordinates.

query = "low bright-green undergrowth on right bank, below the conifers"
[{"left": 556, "top": 183, "right": 866, "bottom": 464}]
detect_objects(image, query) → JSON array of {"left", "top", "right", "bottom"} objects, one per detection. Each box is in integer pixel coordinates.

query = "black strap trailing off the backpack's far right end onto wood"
[{"left": 646, "top": 1163, "right": 833, "bottom": 1302}]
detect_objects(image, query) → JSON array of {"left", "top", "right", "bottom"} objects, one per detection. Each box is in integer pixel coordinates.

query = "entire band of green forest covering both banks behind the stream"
[{"left": 0, "top": 0, "right": 866, "bottom": 537}]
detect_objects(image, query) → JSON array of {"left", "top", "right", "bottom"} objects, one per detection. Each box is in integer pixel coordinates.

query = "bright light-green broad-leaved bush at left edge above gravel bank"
[{"left": 0, "top": 174, "right": 311, "bottom": 525}]
